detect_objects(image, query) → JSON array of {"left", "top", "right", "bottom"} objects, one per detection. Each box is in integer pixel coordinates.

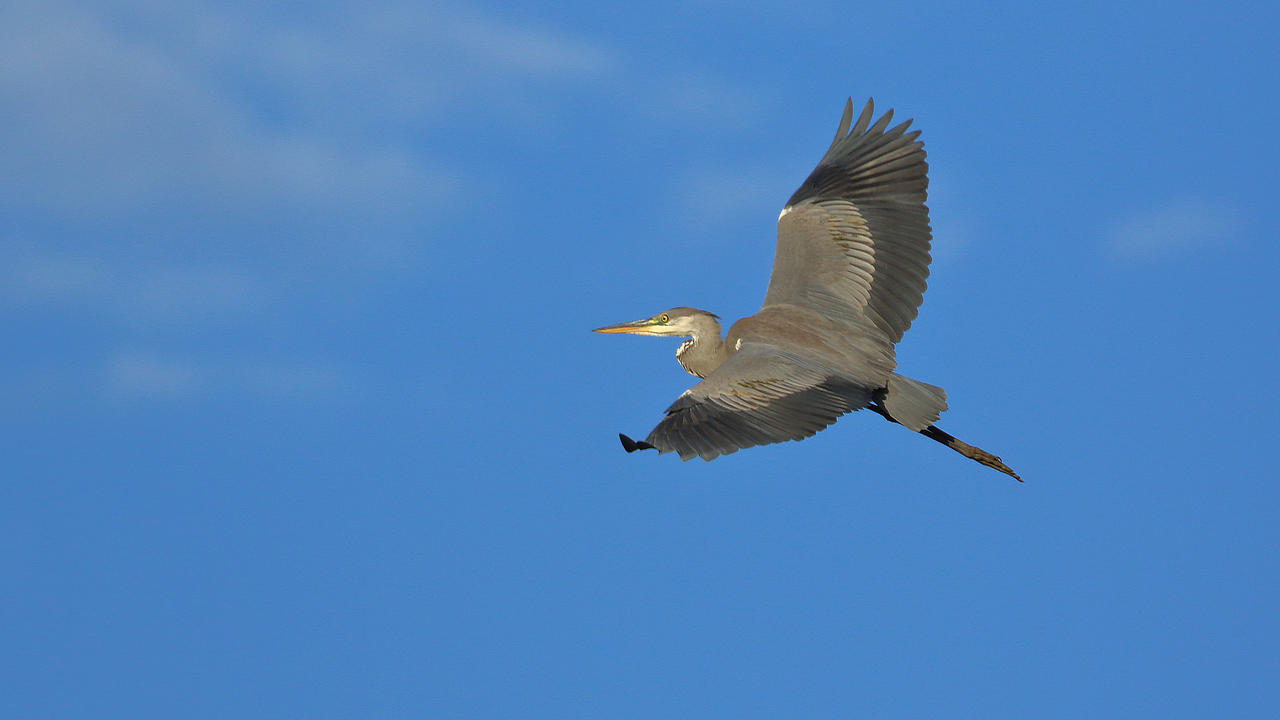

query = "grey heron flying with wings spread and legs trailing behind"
[{"left": 595, "top": 99, "right": 1021, "bottom": 482}]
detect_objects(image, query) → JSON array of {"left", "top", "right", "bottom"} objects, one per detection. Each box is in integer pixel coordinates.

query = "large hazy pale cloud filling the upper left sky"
[{"left": 0, "top": 0, "right": 620, "bottom": 320}]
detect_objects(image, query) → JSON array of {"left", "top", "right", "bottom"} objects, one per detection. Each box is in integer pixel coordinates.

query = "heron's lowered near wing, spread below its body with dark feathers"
[{"left": 645, "top": 342, "right": 870, "bottom": 460}]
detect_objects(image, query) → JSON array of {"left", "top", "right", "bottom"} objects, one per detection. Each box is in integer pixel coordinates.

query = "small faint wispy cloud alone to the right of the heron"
[{"left": 1106, "top": 200, "right": 1240, "bottom": 261}]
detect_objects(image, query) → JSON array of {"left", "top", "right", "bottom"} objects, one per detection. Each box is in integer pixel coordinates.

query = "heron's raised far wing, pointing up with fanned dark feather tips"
[{"left": 764, "top": 100, "right": 929, "bottom": 342}]
